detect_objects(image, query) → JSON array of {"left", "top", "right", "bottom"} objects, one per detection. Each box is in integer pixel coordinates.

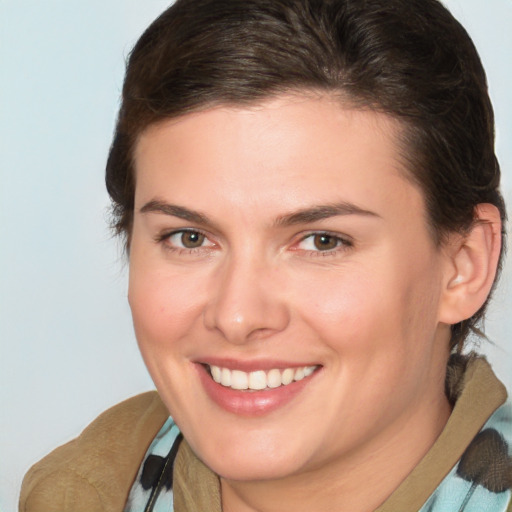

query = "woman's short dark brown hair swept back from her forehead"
[{"left": 106, "top": 0, "right": 506, "bottom": 349}]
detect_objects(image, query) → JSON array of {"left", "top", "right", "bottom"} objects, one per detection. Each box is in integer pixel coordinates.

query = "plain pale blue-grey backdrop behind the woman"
[{"left": 0, "top": 0, "right": 512, "bottom": 512}]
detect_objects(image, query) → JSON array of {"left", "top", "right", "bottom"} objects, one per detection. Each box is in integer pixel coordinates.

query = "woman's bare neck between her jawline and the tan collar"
[{"left": 221, "top": 394, "right": 451, "bottom": 512}]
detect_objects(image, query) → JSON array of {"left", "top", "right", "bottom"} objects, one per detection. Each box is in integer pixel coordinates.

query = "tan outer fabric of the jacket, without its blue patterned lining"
[{"left": 19, "top": 359, "right": 512, "bottom": 512}]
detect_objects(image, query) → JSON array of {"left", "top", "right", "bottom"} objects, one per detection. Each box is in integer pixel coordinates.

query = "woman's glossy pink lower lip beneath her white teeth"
[{"left": 197, "top": 364, "right": 317, "bottom": 416}]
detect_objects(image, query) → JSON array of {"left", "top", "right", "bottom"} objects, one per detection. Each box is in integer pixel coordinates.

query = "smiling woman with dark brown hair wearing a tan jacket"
[{"left": 21, "top": 0, "right": 512, "bottom": 512}]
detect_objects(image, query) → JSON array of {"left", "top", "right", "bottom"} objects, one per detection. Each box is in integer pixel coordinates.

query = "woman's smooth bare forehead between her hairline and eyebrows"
[{"left": 131, "top": 95, "right": 420, "bottom": 222}]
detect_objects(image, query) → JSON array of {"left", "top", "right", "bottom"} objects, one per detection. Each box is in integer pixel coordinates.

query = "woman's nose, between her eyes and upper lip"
[{"left": 204, "top": 252, "right": 290, "bottom": 344}]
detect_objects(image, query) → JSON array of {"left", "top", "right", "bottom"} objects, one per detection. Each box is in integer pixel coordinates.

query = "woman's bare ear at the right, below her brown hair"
[{"left": 439, "top": 203, "right": 501, "bottom": 324}]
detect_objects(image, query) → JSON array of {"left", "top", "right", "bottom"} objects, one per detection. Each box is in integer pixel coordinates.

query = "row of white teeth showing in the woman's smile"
[{"left": 205, "top": 365, "right": 319, "bottom": 391}]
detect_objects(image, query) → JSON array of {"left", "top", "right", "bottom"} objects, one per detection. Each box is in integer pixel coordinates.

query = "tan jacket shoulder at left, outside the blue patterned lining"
[{"left": 19, "top": 391, "right": 169, "bottom": 512}]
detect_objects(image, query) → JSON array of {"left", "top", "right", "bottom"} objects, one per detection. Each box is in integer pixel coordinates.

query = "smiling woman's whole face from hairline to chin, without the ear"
[{"left": 129, "top": 95, "right": 449, "bottom": 480}]
